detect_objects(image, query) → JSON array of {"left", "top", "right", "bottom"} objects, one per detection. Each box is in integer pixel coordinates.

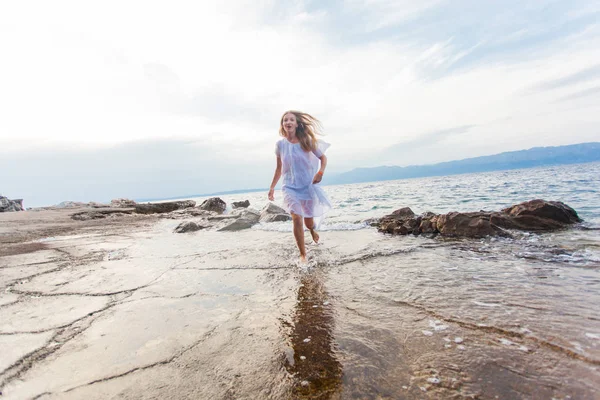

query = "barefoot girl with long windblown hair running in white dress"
[{"left": 269, "top": 111, "right": 331, "bottom": 262}]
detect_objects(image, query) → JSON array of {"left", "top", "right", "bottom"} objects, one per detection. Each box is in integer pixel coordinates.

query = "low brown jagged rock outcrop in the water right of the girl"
[{"left": 378, "top": 200, "right": 581, "bottom": 238}]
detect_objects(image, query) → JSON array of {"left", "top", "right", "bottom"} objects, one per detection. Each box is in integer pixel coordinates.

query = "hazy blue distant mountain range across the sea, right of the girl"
[{"left": 326, "top": 142, "right": 600, "bottom": 185}]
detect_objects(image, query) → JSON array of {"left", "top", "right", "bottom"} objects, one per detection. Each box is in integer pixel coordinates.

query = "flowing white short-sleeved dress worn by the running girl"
[{"left": 275, "top": 138, "right": 331, "bottom": 218}]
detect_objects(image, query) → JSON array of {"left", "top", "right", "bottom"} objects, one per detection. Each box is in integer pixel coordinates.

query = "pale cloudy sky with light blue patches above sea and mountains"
[{"left": 0, "top": 0, "right": 600, "bottom": 207}]
